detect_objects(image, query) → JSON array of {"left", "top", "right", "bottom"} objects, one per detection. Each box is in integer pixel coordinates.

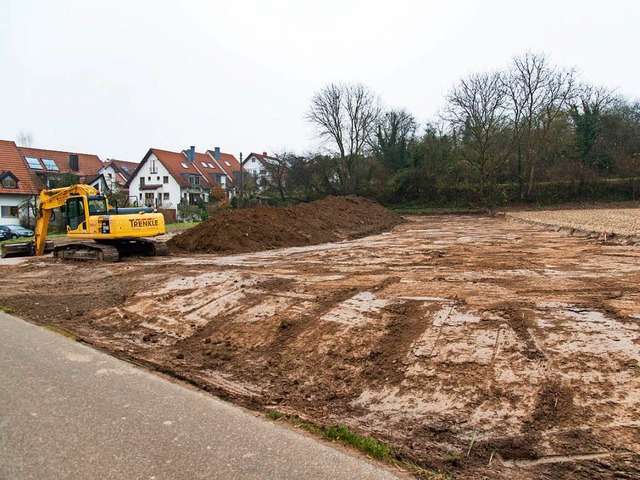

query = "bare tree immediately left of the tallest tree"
[{"left": 445, "top": 73, "right": 510, "bottom": 200}]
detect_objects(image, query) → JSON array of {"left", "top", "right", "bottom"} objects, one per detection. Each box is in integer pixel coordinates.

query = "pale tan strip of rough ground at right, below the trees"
[{"left": 505, "top": 208, "right": 640, "bottom": 237}]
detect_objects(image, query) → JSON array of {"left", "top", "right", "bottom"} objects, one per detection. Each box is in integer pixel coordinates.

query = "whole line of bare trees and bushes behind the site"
[{"left": 250, "top": 53, "right": 640, "bottom": 206}]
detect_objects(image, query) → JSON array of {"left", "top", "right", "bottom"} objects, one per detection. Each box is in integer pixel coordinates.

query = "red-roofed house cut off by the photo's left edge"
[{"left": 0, "top": 140, "right": 41, "bottom": 225}]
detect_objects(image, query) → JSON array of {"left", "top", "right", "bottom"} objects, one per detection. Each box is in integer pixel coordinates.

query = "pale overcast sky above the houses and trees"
[{"left": 0, "top": 0, "right": 640, "bottom": 161}]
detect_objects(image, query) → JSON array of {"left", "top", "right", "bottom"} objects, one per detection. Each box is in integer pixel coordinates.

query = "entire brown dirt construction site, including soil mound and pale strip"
[{"left": 0, "top": 198, "right": 640, "bottom": 480}]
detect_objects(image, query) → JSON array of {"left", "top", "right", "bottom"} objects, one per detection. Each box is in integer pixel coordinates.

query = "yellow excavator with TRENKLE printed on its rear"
[{"left": 2, "top": 184, "right": 166, "bottom": 262}]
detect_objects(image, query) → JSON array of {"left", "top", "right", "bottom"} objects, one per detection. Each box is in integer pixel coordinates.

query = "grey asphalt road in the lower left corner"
[{"left": 0, "top": 312, "right": 398, "bottom": 479}]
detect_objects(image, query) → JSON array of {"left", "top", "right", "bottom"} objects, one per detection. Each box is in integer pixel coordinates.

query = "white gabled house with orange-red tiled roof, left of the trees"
[{"left": 126, "top": 147, "right": 240, "bottom": 216}]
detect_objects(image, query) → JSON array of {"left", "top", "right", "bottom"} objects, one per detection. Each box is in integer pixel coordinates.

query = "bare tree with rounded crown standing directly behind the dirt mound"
[{"left": 306, "top": 83, "right": 380, "bottom": 192}]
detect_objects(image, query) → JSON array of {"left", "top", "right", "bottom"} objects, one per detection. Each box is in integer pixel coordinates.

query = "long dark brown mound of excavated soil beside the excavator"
[{"left": 168, "top": 196, "right": 402, "bottom": 253}]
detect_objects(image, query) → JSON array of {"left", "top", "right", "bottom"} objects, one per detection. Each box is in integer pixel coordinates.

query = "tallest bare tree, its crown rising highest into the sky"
[{"left": 504, "top": 52, "right": 576, "bottom": 196}]
